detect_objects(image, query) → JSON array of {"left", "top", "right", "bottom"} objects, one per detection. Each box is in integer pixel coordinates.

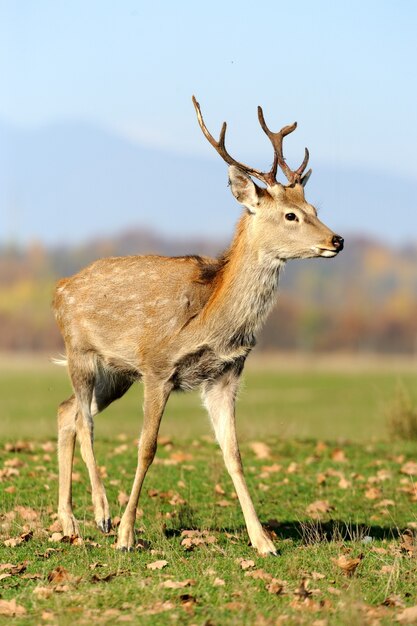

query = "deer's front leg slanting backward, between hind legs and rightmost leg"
[{"left": 117, "top": 380, "right": 171, "bottom": 550}]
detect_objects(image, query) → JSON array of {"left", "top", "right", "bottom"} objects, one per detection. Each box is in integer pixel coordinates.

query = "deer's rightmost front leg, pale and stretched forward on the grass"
[{"left": 202, "top": 372, "right": 276, "bottom": 554}]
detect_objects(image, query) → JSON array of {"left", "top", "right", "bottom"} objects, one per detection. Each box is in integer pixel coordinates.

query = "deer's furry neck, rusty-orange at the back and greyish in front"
[{"left": 205, "top": 215, "right": 284, "bottom": 347}]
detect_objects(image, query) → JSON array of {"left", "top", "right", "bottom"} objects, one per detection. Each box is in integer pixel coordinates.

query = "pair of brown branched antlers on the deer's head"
[{"left": 192, "top": 96, "right": 310, "bottom": 186}]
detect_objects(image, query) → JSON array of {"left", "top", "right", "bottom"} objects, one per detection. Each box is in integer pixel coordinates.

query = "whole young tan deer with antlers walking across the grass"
[{"left": 52, "top": 96, "right": 344, "bottom": 555}]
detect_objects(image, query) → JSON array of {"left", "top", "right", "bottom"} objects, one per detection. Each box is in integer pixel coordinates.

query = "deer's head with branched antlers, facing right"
[{"left": 193, "top": 96, "right": 343, "bottom": 260}]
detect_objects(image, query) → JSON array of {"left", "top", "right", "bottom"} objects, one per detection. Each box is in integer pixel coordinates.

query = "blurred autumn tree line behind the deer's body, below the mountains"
[{"left": 0, "top": 230, "right": 417, "bottom": 354}]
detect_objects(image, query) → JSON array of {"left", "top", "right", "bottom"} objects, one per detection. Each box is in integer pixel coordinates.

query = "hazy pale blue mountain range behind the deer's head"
[{"left": 0, "top": 117, "right": 417, "bottom": 244}]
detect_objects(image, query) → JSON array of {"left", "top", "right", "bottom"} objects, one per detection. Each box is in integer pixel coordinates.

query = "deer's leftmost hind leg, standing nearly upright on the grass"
[{"left": 58, "top": 396, "right": 79, "bottom": 536}]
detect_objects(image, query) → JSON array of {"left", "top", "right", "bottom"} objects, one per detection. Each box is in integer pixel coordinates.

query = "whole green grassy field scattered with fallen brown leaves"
[{"left": 0, "top": 359, "right": 417, "bottom": 626}]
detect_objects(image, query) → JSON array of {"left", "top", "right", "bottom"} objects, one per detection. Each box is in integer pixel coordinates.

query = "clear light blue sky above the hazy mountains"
[{"left": 0, "top": 0, "right": 417, "bottom": 241}]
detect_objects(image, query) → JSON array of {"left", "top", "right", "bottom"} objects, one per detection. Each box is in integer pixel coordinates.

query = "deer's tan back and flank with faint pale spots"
[{"left": 53, "top": 251, "right": 217, "bottom": 360}]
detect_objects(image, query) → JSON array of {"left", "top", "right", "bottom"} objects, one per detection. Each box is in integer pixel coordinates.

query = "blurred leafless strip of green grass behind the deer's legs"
[{"left": 0, "top": 359, "right": 417, "bottom": 441}]
